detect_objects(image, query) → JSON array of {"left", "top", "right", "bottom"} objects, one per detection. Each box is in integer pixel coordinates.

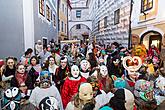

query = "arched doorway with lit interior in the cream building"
[{"left": 140, "top": 31, "right": 162, "bottom": 50}]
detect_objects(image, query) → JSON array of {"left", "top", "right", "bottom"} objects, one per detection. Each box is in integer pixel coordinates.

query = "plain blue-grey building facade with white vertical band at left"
[{"left": 0, "top": 0, "right": 58, "bottom": 58}]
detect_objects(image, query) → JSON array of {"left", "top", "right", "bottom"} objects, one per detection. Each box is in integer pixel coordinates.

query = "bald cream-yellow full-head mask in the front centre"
[{"left": 78, "top": 83, "right": 93, "bottom": 102}]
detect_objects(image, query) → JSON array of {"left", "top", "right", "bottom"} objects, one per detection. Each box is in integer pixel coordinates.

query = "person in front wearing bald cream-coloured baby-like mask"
[{"left": 65, "top": 83, "right": 99, "bottom": 110}]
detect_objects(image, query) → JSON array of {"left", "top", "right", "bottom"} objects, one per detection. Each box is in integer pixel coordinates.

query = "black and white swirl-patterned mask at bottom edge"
[{"left": 39, "top": 97, "right": 58, "bottom": 110}]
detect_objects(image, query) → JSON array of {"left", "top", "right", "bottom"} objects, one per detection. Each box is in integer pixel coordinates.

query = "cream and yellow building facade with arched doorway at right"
[{"left": 132, "top": 0, "right": 165, "bottom": 50}]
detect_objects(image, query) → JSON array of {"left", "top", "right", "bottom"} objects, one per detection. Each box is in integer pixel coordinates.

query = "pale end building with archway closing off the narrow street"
[{"left": 69, "top": 0, "right": 92, "bottom": 41}]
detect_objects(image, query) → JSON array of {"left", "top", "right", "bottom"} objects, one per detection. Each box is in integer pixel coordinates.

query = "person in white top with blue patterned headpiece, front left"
[{"left": 29, "top": 71, "right": 63, "bottom": 110}]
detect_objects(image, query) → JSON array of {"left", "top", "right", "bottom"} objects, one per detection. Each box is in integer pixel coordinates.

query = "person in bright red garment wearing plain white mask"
[{"left": 61, "top": 65, "right": 86, "bottom": 108}]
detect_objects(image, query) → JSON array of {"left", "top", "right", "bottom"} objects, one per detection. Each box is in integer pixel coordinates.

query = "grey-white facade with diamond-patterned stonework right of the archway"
[{"left": 87, "top": 0, "right": 131, "bottom": 47}]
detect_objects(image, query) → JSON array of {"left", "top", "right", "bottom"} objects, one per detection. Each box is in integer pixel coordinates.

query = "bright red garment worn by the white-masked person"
[{"left": 61, "top": 77, "right": 86, "bottom": 109}]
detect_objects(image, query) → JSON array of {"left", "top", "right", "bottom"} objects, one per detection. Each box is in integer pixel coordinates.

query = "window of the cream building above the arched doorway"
[{"left": 141, "top": 0, "right": 153, "bottom": 13}]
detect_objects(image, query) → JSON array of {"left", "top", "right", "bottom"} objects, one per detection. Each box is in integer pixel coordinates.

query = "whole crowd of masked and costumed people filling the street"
[{"left": 0, "top": 40, "right": 165, "bottom": 110}]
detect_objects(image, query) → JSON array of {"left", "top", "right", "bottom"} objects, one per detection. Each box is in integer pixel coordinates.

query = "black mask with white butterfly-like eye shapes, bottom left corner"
[{"left": 3, "top": 87, "right": 21, "bottom": 110}]
